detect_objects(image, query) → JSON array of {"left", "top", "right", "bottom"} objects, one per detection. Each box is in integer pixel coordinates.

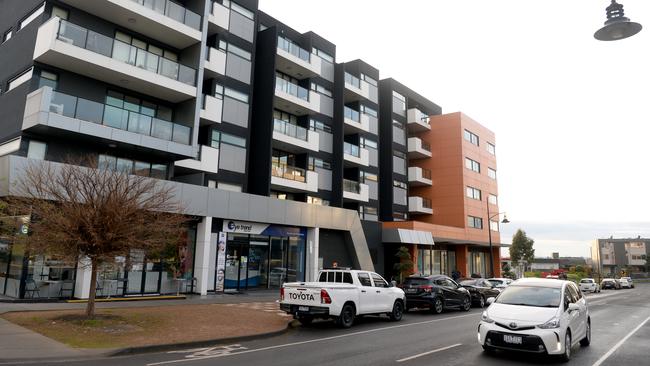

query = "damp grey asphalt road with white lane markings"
[{"left": 10, "top": 284, "right": 650, "bottom": 366}]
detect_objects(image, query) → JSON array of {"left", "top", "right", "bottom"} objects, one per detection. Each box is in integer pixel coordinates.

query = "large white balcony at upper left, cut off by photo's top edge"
[{"left": 62, "top": 0, "right": 202, "bottom": 49}]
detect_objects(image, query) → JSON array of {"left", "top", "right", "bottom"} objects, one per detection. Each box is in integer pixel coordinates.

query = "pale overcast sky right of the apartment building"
[{"left": 259, "top": 0, "right": 650, "bottom": 257}]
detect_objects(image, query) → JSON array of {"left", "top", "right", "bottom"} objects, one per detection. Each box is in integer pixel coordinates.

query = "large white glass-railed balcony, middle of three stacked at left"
[{"left": 34, "top": 17, "right": 196, "bottom": 103}]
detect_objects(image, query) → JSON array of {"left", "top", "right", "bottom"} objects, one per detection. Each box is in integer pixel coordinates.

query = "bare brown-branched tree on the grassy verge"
[{"left": 11, "top": 158, "right": 187, "bottom": 317}]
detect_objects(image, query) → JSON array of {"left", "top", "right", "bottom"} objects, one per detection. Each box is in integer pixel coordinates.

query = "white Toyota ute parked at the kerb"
[{"left": 280, "top": 269, "right": 405, "bottom": 328}]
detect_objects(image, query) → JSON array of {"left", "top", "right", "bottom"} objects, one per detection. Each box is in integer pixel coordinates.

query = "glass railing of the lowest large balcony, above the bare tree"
[{"left": 50, "top": 91, "right": 192, "bottom": 145}]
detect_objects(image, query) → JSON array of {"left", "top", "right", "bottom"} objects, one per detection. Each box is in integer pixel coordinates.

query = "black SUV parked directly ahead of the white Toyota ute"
[{"left": 402, "top": 275, "right": 472, "bottom": 314}]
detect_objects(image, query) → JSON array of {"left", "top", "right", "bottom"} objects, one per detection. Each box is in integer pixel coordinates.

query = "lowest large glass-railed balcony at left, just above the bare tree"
[{"left": 22, "top": 86, "right": 196, "bottom": 158}]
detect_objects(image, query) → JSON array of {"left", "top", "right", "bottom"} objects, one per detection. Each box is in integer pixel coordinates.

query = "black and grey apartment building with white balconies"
[{"left": 0, "top": 0, "right": 498, "bottom": 298}]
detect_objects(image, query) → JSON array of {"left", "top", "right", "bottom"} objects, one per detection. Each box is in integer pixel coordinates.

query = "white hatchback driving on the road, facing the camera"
[{"left": 478, "top": 278, "right": 591, "bottom": 361}]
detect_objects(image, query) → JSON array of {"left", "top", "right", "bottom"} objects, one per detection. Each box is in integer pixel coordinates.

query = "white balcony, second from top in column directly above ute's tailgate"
[{"left": 274, "top": 77, "right": 334, "bottom": 117}]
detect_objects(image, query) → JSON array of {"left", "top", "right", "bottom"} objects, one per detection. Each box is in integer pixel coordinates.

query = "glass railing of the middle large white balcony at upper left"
[{"left": 57, "top": 20, "right": 196, "bottom": 86}]
